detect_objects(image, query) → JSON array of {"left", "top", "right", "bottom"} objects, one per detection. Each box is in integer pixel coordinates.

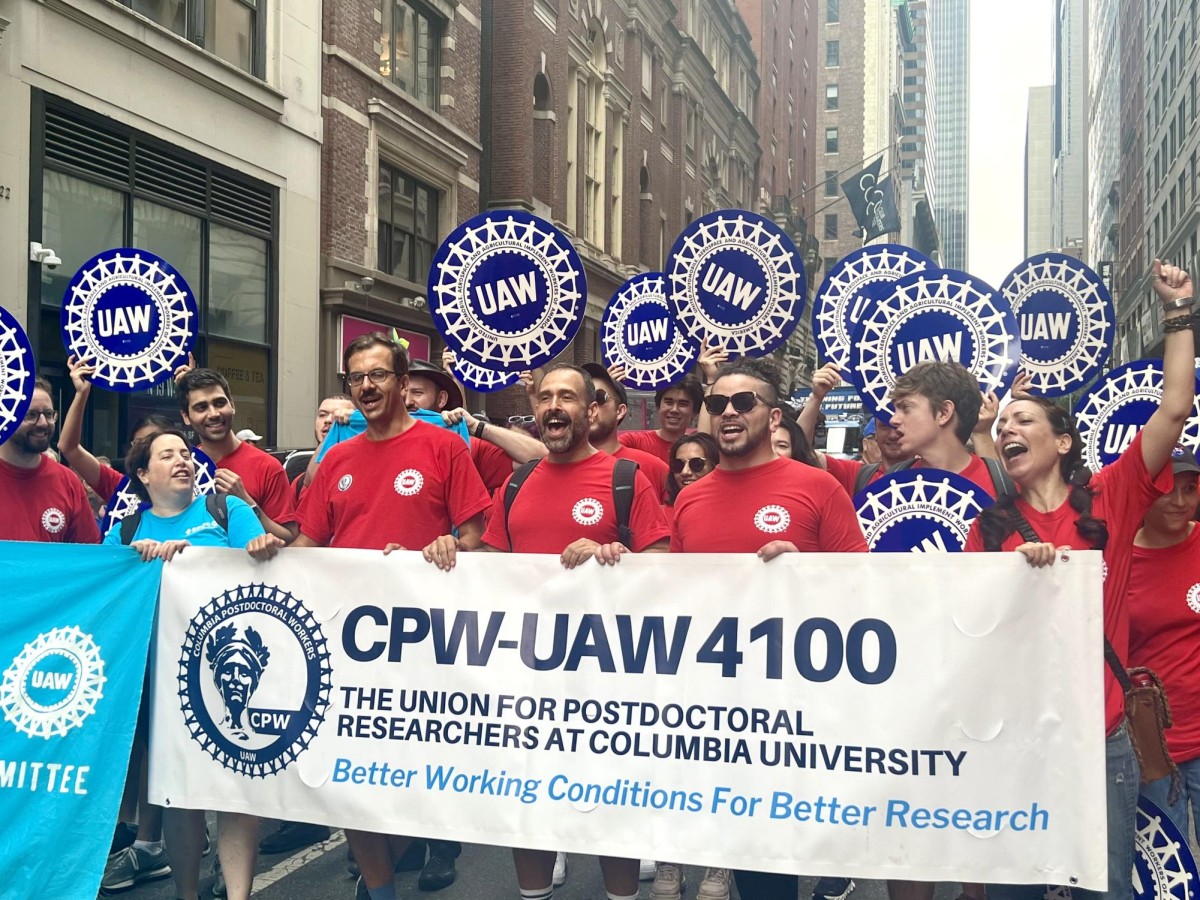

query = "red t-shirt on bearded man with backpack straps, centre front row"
[{"left": 484, "top": 451, "right": 671, "bottom": 553}]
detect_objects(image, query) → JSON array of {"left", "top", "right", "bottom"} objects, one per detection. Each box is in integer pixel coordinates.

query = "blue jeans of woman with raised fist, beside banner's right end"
[{"left": 988, "top": 725, "right": 1137, "bottom": 900}]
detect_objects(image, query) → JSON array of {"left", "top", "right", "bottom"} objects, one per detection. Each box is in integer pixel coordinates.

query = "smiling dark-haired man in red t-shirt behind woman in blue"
[{"left": 175, "top": 368, "right": 298, "bottom": 541}]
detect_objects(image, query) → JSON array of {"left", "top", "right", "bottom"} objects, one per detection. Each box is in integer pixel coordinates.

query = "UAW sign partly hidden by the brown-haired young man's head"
[{"left": 850, "top": 269, "right": 1021, "bottom": 419}]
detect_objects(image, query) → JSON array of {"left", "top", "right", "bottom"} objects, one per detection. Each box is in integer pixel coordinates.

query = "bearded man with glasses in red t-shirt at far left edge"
[{"left": 0, "top": 378, "right": 100, "bottom": 544}]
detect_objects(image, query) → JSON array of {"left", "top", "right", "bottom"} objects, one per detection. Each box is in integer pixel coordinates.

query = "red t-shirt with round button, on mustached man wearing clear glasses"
[{"left": 299, "top": 421, "right": 491, "bottom": 550}]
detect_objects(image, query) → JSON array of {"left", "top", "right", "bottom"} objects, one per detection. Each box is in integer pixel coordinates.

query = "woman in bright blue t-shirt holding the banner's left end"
[{"left": 104, "top": 430, "right": 283, "bottom": 900}]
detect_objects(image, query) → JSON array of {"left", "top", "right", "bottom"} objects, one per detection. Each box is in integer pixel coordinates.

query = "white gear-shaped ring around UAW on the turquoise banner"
[{"left": 0, "top": 625, "right": 108, "bottom": 740}]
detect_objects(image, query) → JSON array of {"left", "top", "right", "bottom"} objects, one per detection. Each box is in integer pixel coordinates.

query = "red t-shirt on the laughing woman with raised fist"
[{"left": 965, "top": 432, "right": 1175, "bottom": 734}]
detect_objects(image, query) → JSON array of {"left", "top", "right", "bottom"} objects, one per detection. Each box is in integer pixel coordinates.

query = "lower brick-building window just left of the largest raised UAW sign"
[{"left": 379, "top": 163, "right": 440, "bottom": 284}]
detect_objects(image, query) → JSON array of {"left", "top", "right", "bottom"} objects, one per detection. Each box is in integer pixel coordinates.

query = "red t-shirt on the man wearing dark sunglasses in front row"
[{"left": 671, "top": 458, "right": 866, "bottom": 553}]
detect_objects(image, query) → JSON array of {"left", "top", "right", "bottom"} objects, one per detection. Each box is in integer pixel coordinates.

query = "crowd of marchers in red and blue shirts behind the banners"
[{"left": 0, "top": 262, "right": 1200, "bottom": 900}]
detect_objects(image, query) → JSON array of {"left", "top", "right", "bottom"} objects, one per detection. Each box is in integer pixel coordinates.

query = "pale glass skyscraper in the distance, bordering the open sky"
[{"left": 929, "top": 0, "right": 971, "bottom": 269}]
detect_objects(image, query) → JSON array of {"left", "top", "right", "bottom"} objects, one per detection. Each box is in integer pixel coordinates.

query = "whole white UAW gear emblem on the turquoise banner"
[{"left": 0, "top": 626, "right": 106, "bottom": 738}]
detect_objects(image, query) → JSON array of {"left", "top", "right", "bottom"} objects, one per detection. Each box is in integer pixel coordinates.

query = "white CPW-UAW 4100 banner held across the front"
[{"left": 150, "top": 548, "right": 1106, "bottom": 889}]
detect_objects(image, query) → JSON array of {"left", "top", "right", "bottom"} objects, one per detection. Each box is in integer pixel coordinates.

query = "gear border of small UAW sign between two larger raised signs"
[{"left": 600, "top": 272, "right": 700, "bottom": 391}]
